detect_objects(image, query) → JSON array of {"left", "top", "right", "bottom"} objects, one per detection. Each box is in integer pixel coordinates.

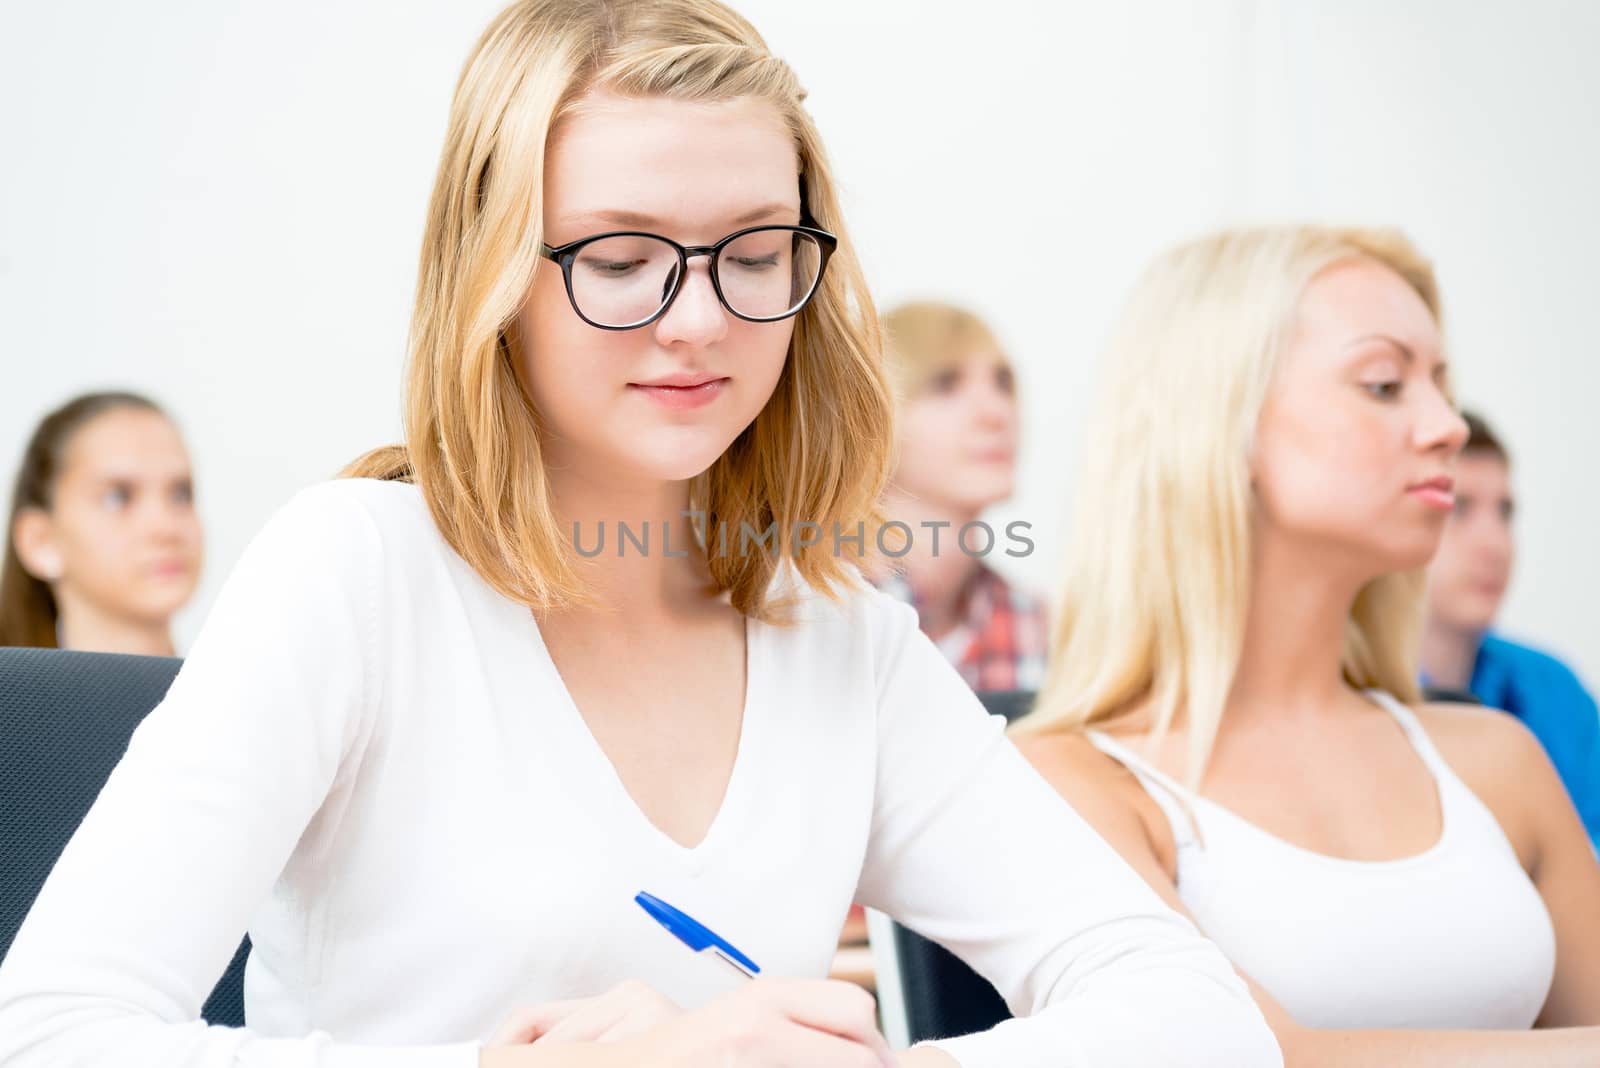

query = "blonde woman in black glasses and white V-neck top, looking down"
[{"left": 0, "top": 0, "right": 1280, "bottom": 1068}]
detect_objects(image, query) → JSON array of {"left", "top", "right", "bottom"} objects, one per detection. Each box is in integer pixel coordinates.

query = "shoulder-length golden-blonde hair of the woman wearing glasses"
[{"left": 344, "top": 0, "right": 893, "bottom": 619}]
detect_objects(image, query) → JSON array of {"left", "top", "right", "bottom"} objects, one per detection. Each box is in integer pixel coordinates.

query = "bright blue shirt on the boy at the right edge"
[{"left": 1470, "top": 635, "right": 1600, "bottom": 841}]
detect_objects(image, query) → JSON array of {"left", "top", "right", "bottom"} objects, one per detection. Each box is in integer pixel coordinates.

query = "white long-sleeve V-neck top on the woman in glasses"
[{"left": 0, "top": 481, "right": 1282, "bottom": 1068}]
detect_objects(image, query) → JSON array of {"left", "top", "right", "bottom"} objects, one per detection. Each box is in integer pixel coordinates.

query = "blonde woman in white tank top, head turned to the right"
[{"left": 1018, "top": 227, "right": 1600, "bottom": 1068}]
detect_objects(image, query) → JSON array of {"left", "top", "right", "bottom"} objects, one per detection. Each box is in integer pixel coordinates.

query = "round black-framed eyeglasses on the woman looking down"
[{"left": 539, "top": 225, "right": 838, "bottom": 329}]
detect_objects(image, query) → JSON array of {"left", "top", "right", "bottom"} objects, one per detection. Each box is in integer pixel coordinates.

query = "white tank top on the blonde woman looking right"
[{"left": 1088, "top": 691, "right": 1555, "bottom": 1030}]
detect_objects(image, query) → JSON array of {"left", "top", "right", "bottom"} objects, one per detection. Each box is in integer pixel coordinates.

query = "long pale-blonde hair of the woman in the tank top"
[{"left": 1016, "top": 225, "right": 1440, "bottom": 787}]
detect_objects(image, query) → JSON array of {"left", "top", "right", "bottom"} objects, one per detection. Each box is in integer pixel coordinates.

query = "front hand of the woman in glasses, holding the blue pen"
[{"left": 480, "top": 978, "right": 894, "bottom": 1068}]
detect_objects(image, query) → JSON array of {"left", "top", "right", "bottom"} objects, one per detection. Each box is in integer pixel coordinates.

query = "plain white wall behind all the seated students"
[{"left": 0, "top": 0, "right": 1600, "bottom": 684}]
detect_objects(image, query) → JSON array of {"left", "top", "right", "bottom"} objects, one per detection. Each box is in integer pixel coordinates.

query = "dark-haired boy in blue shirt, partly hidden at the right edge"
[{"left": 1422, "top": 412, "right": 1600, "bottom": 841}]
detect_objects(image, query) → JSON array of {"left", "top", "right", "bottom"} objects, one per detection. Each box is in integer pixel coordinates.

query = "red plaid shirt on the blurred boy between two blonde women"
[{"left": 883, "top": 566, "right": 1048, "bottom": 691}]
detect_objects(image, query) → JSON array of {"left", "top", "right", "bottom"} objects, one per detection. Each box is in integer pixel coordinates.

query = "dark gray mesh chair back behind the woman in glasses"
[{"left": 0, "top": 648, "right": 250, "bottom": 1026}]
